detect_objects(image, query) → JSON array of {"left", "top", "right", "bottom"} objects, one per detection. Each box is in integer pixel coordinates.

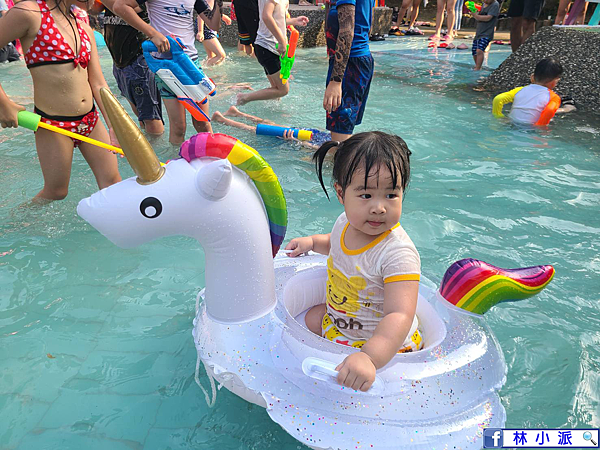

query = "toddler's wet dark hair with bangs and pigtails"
[{"left": 313, "top": 131, "right": 411, "bottom": 198}]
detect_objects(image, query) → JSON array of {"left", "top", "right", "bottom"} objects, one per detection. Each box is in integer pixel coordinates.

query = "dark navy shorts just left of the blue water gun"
[{"left": 113, "top": 55, "right": 162, "bottom": 121}]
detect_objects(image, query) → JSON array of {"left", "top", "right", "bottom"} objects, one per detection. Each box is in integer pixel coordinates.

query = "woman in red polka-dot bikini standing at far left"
[{"left": 0, "top": 0, "right": 121, "bottom": 203}]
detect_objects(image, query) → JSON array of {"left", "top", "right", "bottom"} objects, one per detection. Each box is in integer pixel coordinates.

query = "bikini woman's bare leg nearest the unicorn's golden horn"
[{"left": 79, "top": 121, "right": 121, "bottom": 189}]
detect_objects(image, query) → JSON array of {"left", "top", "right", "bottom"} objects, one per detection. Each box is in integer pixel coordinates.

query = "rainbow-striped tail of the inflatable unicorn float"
[{"left": 440, "top": 258, "right": 554, "bottom": 314}]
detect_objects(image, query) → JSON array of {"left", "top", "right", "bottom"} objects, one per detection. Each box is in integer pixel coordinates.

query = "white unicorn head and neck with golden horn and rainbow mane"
[{"left": 77, "top": 91, "right": 287, "bottom": 323}]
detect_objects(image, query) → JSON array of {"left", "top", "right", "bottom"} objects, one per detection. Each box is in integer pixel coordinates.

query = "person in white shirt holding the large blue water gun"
[{"left": 112, "top": 0, "right": 223, "bottom": 145}]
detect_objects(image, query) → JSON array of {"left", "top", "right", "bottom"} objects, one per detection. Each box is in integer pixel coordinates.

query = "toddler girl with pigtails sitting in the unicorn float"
[{"left": 286, "top": 131, "right": 422, "bottom": 391}]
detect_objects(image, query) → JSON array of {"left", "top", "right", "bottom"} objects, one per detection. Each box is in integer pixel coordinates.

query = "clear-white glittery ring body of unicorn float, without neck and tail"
[{"left": 193, "top": 254, "right": 506, "bottom": 450}]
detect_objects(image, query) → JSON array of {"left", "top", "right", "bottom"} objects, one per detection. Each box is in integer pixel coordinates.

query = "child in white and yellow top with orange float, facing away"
[{"left": 492, "top": 58, "right": 563, "bottom": 126}]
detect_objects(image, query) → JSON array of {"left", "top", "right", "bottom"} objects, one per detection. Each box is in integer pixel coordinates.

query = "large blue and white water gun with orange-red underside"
[{"left": 142, "top": 36, "right": 217, "bottom": 122}]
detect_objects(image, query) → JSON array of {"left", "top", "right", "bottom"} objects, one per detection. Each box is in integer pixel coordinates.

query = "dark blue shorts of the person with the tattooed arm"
[{"left": 326, "top": 54, "right": 375, "bottom": 134}]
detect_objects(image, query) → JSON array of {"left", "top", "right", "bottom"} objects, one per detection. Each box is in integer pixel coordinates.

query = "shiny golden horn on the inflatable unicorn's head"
[{"left": 100, "top": 88, "right": 165, "bottom": 184}]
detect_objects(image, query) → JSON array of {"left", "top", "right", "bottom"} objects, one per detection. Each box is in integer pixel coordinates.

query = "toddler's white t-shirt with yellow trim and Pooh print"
[{"left": 327, "top": 213, "right": 421, "bottom": 339}]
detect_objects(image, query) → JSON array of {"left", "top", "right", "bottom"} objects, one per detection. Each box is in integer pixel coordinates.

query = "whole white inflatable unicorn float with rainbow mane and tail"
[{"left": 77, "top": 91, "right": 554, "bottom": 450}]
